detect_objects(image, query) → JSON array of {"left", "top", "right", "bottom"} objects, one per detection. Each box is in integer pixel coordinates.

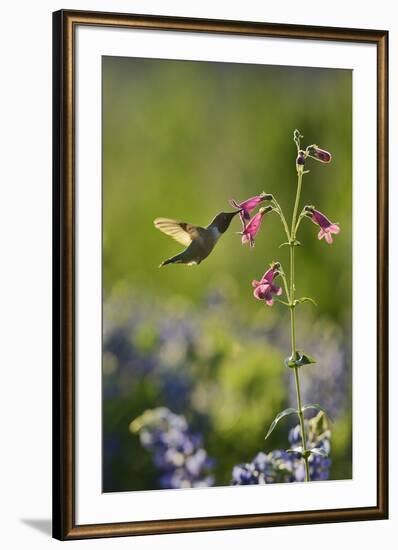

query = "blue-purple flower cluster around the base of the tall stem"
[{"left": 231, "top": 416, "right": 332, "bottom": 485}]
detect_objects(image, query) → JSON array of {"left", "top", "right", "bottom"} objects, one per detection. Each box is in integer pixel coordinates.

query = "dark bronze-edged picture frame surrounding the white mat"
[{"left": 53, "top": 10, "right": 388, "bottom": 540}]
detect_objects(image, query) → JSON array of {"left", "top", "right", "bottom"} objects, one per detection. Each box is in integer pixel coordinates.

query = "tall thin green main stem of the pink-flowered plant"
[{"left": 289, "top": 172, "right": 310, "bottom": 481}]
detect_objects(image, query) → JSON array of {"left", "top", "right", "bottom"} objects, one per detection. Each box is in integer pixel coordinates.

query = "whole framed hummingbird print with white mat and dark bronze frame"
[{"left": 53, "top": 11, "right": 388, "bottom": 540}]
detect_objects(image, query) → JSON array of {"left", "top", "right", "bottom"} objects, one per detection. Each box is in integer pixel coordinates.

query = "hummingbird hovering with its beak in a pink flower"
[{"left": 153, "top": 210, "right": 240, "bottom": 267}]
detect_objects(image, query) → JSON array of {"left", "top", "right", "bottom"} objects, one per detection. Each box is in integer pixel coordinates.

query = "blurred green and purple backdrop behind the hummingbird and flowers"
[{"left": 103, "top": 57, "right": 352, "bottom": 491}]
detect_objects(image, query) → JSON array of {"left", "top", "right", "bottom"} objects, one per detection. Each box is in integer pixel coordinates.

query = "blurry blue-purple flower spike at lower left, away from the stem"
[{"left": 130, "top": 407, "right": 214, "bottom": 489}]
